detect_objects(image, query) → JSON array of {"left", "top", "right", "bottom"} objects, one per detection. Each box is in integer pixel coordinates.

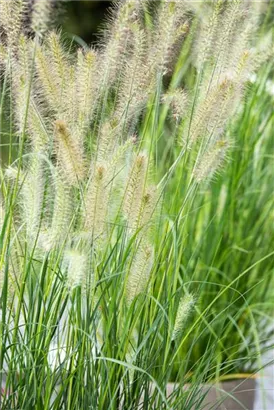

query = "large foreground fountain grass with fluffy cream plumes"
[{"left": 0, "top": 0, "right": 273, "bottom": 410}]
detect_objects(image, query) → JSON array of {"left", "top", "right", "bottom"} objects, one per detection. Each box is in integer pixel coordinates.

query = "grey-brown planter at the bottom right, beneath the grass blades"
[{"left": 167, "top": 379, "right": 256, "bottom": 410}]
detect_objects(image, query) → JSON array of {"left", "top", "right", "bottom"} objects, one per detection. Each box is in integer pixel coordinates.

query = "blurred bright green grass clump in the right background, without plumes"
[{"left": 164, "top": 64, "right": 274, "bottom": 381}]
